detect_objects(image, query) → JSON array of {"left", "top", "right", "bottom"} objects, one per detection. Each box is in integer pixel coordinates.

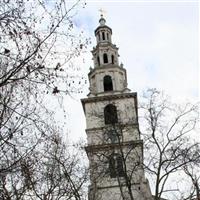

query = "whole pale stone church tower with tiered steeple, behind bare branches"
[{"left": 81, "top": 16, "right": 152, "bottom": 200}]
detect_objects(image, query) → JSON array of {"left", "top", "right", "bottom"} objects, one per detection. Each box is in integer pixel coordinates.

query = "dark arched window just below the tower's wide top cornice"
[{"left": 104, "top": 104, "right": 118, "bottom": 124}]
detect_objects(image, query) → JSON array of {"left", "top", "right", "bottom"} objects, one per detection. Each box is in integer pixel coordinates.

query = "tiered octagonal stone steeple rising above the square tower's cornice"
[{"left": 88, "top": 15, "right": 129, "bottom": 97}]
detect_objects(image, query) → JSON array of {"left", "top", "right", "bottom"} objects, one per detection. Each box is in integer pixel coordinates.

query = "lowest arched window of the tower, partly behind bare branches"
[{"left": 109, "top": 153, "right": 124, "bottom": 178}]
